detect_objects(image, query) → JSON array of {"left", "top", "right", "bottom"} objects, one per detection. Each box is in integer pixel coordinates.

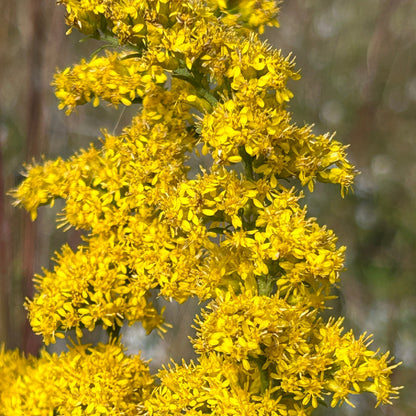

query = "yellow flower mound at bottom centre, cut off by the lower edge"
[{"left": 146, "top": 354, "right": 288, "bottom": 416}]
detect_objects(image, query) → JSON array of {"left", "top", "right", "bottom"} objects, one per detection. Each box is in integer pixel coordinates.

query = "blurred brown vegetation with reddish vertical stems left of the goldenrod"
[{"left": 0, "top": 0, "right": 133, "bottom": 352}]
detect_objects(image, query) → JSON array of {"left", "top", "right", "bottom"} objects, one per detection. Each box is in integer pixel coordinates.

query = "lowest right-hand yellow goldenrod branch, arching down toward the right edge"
[{"left": 194, "top": 292, "right": 400, "bottom": 408}]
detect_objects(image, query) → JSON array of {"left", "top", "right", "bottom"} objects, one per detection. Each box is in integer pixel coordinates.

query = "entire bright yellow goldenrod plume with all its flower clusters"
[{"left": 0, "top": 0, "right": 397, "bottom": 416}]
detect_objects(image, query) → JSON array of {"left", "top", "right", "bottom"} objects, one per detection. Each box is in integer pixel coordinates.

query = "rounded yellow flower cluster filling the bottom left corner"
[{"left": 0, "top": 343, "right": 154, "bottom": 416}]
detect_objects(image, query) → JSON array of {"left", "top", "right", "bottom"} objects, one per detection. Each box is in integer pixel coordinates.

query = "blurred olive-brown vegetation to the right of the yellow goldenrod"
[{"left": 269, "top": 0, "right": 416, "bottom": 416}]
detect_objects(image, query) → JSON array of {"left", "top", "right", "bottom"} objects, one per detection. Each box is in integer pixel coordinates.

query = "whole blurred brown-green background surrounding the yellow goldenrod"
[{"left": 0, "top": 0, "right": 416, "bottom": 416}]
